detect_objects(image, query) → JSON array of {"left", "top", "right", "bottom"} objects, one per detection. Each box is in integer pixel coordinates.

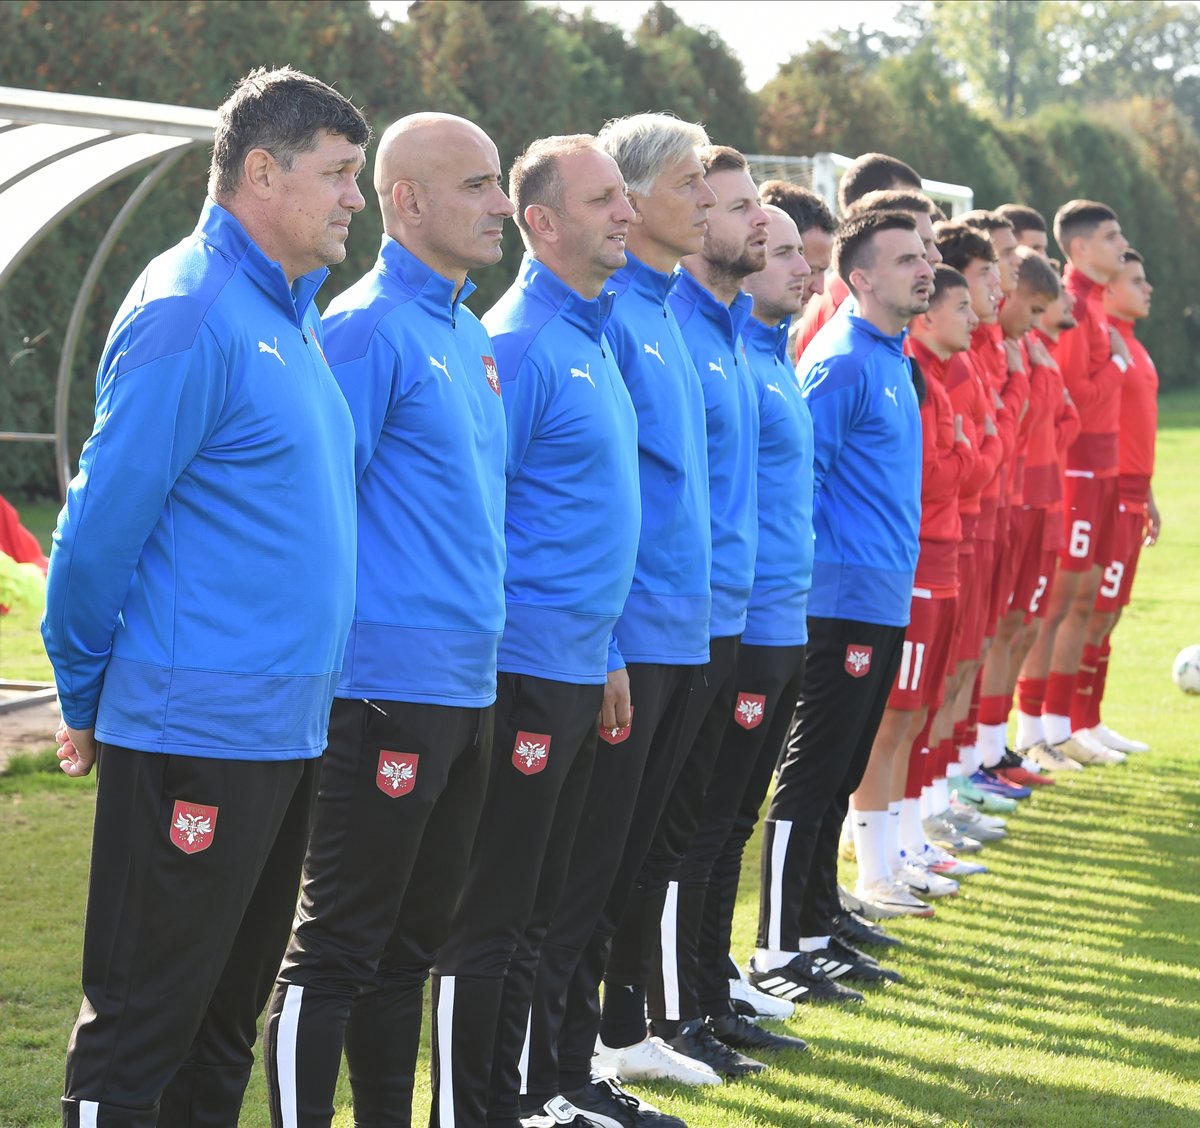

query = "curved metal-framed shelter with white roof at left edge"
[{"left": 0, "top": 86, "right": 217, "bottom": 498}]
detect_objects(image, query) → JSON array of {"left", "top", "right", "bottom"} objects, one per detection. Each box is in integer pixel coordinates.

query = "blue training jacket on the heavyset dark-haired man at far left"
[{"left": 42, "top": 200, "right": 355, "bottom": 760}]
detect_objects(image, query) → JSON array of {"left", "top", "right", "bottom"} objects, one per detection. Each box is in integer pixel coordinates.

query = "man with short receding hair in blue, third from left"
[{"left": 431, "top": 134, "right": 641, "bottom": 1128}]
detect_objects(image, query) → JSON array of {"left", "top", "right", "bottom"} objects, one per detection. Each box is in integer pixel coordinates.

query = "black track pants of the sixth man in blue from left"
[{"left": 648, "top": 646, "right": 804, "bottom": 1021}]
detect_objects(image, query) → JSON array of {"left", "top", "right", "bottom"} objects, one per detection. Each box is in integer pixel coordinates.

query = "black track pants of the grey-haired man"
[{"left": 516, "top": 662, "right": 698, "bottom": 1117}]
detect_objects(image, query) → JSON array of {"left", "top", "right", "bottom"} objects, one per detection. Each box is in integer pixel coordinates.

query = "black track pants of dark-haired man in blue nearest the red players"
[{"left": 758, "top": 618, "right": 904, "bottom": 952}]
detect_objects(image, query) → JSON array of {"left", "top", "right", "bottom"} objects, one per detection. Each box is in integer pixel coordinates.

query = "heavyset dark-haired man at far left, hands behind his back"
[{"left": 42, "top": 68, "right": 371, "bottom": 1128}]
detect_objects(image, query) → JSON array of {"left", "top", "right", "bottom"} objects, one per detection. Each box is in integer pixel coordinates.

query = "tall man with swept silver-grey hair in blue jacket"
[{"left": 512, "top": 114, "right": 719, "bottom": 1128}]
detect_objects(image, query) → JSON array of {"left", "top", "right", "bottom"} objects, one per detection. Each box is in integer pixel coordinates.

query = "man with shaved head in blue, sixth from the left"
[{"left": 647, "top": 206, "right": 812, "bottom": 1068}]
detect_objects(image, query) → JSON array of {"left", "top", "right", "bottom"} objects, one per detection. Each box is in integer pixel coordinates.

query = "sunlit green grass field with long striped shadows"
[{"left": 0, "top": 392, "right": 1200, "bottom": 1128}]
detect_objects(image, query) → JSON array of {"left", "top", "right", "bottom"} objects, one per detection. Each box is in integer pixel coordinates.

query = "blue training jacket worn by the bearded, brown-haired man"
[{"left": 668, "top": 268, "right": 758, "bottom": 638}]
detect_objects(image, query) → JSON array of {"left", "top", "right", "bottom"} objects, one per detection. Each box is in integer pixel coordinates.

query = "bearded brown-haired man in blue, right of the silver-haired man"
[{"left": 600, "top": 145, "right": 767, "bottom": 1076}]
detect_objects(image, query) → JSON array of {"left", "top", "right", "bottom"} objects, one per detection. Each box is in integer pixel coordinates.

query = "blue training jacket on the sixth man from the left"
[{"left": 742, "top": 317, "right": 812, "bottom": 647}]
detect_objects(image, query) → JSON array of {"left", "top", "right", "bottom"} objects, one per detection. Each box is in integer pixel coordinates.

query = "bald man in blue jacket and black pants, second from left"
[{"left": 264, "top": 114, "right": 514, "bottom": 1128}]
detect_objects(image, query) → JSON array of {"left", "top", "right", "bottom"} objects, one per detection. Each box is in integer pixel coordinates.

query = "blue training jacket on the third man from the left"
[{"left": 484, "top": 254, "right": 642, "bottom": 685}]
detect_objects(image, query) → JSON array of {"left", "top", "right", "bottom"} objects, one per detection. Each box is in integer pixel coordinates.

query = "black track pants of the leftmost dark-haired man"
[{"left": 62, "top": 745, "right": 320, "bottom": 1128}]
